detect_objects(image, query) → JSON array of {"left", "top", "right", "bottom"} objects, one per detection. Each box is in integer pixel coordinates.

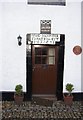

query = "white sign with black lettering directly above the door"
[{"left": 31, "top": 33, "right": 60, "bottom": 45}]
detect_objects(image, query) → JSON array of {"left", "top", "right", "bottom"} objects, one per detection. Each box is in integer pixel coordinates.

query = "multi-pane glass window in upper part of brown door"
[{"left": 35, "top": 47, "right": 55, "bottom": 65}]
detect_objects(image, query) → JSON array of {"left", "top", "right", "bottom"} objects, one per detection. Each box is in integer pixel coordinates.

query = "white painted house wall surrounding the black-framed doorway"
[{"left": 0, "top": 2, "right": 81, "bottom": 92}]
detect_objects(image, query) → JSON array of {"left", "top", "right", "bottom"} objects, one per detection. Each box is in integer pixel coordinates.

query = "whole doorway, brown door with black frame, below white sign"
[{"left": 26, "top": 34, "right": 65, "bottom": 100}]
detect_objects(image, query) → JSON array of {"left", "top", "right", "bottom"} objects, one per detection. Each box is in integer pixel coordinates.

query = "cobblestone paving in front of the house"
[{"left": 1, "top": 101, "right": 83, "bottom": 120}]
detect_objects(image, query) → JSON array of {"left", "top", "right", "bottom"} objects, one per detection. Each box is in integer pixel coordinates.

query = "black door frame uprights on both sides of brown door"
[{"left": 26, "top": 34, "right": 65, "bottom": 100}]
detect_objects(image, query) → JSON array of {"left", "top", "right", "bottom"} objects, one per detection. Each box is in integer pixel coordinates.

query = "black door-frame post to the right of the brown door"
[{"left": 56, "top": 34, "right": 65, "bottom": 100}]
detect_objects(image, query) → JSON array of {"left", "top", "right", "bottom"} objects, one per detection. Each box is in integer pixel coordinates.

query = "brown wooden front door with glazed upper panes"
[{"left": 32, "top": 45, "right": 58, "bottom": 95}]
